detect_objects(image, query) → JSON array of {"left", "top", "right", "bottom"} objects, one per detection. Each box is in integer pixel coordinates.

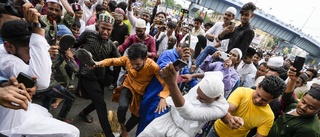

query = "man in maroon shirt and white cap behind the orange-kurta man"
[{"left": 118, "top": 19, "right": 157, "bottom": 59}]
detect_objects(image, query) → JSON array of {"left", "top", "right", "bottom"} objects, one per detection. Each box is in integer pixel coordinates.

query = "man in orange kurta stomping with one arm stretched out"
[{"left": 95, "top": 43, "right": 169, "bottom": 136}]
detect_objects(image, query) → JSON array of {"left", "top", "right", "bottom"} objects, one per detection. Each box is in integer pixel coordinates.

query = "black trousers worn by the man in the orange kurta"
[{"left": 117, "top": 87, "right": 140, "bottom": 132}]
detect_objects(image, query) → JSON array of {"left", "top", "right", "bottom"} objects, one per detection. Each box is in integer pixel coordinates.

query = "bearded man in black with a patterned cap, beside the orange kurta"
[{"left": 75, "top": 14, "right": 120, "bottom": 137}]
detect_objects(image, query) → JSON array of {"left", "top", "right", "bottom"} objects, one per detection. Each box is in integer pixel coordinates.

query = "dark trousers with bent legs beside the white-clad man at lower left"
[{"left": 42, "top": 85, "right": 75, "bottom": 120}]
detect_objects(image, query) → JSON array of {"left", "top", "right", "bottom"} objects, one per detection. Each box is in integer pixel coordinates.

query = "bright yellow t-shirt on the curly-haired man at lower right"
[{"left": 214, "top": 87, "right": 274, "bottom": 137}]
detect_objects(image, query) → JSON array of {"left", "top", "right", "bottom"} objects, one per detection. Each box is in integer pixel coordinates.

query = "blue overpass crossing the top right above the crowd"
[{"left": 191, "top": 0, "right": 320, "bottom": 63}]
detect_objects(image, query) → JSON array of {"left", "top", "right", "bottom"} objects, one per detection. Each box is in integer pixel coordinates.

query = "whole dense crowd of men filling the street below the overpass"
[{"left": 0, "top": 0, "right": 320, "bottom": 137}]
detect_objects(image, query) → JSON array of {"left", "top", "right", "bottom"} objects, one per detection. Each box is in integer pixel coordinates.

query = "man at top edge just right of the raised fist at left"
[{"left": 40, "top": 0, "right": 74, "bottom": 36}]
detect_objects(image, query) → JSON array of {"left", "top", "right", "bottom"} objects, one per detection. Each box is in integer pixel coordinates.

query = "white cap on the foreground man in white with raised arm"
[{"left": 199, "top": 71, "right": 224, "bottom": 98}]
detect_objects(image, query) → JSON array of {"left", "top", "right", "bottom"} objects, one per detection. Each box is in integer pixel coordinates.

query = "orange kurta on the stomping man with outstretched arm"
[{"left": 102, "top": 56, "right": 170, "bottom": 116}]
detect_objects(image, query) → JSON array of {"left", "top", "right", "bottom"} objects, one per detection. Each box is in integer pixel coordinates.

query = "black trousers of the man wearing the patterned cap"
[{"left": 80, "top": 77, "right": 114, "bottom": 137}]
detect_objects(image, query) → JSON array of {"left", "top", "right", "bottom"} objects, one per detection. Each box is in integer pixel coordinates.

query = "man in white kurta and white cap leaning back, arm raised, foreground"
[{"left": 138, "top": 69, "right": 229, "bottom": 137}]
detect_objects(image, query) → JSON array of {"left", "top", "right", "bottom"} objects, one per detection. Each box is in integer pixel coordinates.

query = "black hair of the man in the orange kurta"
[{"left": 128, "top": 43, "right": 148, "bottom": 60}]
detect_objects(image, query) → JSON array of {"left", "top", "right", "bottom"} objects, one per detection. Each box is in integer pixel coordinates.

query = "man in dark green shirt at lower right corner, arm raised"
[{"left": 268, "top": 66, "right": 320, "bottom": 137}]
